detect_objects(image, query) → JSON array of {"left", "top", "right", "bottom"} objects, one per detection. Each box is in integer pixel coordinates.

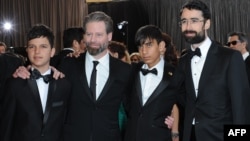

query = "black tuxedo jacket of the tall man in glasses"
[{"left": 179, "top": 42, "right": 250, "bottom": 141}]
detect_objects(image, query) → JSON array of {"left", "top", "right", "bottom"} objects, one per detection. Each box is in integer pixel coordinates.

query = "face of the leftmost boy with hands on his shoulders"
[{"left": 26, "top": 37, "right": 55, "bottom": 73}]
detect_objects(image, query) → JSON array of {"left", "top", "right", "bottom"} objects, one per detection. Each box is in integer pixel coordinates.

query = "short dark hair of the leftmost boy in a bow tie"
[{"left": 27, "top": 24, "right": 55, "bottom": 48}]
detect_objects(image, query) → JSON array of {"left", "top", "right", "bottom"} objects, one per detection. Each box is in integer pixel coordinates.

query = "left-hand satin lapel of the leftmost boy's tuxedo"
[{"left": 27, "top": 79, "right": 43, "bottom": 114}]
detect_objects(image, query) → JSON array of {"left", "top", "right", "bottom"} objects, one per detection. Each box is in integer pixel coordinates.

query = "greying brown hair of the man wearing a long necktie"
[{"left": 83, "top": 11, "right": 114, "bottom": 33}]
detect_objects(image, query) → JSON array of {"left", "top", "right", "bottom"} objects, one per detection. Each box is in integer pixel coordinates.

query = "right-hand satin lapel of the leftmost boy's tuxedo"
[{"left": 43, "top": 80, "right": 57, "bottom": 125}]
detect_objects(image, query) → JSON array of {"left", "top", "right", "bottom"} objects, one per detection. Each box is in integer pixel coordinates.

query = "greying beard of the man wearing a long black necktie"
[{"left": 86, "top": 42, "right": 108, "bottom": 56}]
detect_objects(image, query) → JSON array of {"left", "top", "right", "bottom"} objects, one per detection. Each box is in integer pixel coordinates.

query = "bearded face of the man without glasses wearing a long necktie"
[{"left": 84, "top": 21, "right": 112, "bottom": 59}]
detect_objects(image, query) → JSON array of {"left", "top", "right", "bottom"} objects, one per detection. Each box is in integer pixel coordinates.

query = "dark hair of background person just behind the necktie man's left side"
[{"left": 63, "top": 27, "right": 84, "bottom": 48}]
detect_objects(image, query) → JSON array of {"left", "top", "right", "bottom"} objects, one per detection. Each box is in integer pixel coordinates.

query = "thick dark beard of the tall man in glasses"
[{"left": 182, "top": 30, "right": 206, "bottom": 44}]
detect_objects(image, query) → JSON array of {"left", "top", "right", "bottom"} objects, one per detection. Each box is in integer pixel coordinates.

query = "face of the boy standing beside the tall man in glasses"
[{"left": 139, "top": 39, "right": 165, "bottom": 68}]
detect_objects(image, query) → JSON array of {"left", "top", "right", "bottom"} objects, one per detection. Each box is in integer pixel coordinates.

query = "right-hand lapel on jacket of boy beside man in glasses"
[{"left": 144, "top": 64, "right": 174, "bottom": 106}]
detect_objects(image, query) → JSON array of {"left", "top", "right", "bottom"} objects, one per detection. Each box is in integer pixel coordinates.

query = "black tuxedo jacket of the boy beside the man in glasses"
[{"left": 125, "top": 63, "right": 181, "bottom": 141}]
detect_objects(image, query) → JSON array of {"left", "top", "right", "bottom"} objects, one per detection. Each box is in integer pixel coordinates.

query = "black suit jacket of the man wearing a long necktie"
[{"left": 59, "top": 53, "right": 131, "bottom": 141}]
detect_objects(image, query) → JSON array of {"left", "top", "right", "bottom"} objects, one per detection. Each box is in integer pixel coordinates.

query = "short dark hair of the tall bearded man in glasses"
[{"left": 180, "top": 0, "right": 211, "bottom": 19}]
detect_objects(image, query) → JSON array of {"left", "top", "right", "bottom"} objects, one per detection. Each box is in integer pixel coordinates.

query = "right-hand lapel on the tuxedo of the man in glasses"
[{"left": 197, "top": 43, "right": 218, "bottom": 98}]
